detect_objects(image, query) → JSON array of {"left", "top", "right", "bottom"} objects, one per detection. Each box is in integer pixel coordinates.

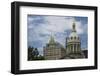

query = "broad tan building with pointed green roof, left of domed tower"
[{"left": 44, "top": 36, "right": 66, "bottom": 60}]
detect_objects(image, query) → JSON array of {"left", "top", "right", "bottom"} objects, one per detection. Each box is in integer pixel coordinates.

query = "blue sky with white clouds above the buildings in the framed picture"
[{"left": 27, "top": 15, "right": 88, "bottom": 55}]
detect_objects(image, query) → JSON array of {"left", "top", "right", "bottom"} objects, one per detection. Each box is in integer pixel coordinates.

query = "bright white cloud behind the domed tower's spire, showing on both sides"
[{"left": 44, "top": 16, "right": 84, "bottom": 34}]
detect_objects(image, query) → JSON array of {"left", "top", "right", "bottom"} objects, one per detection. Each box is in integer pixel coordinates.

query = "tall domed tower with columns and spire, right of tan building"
[{"left": 66, "top": 19, "right": 84, "bottom": 58}]
